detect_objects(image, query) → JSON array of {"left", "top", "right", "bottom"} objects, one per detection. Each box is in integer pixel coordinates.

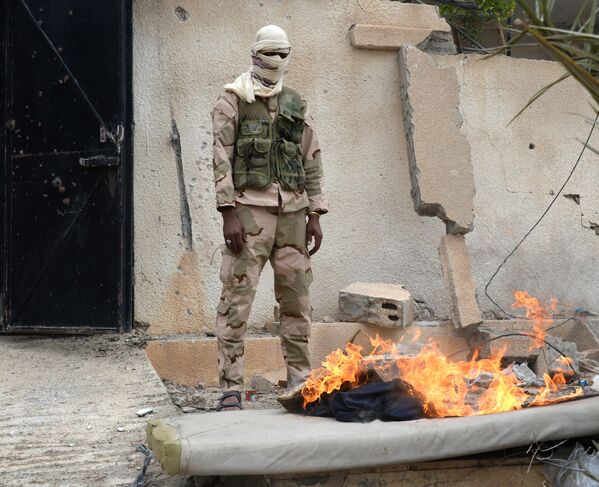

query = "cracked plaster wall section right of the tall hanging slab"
[{"left": 458, "top": 56, "right": 599, "bottom": 316}]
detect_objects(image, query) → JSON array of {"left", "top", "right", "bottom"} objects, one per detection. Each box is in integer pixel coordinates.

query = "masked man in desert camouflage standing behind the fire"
[{"left": 212, "top": 25, "right": 328, "bottom": 410}]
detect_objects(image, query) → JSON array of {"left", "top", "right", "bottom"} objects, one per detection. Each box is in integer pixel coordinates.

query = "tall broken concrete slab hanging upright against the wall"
[{"left": 399, "top": 46, "right": 475, "bottom": 234}]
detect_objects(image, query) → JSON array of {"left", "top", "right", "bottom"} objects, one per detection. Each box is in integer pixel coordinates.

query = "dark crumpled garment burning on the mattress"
[{"left": 305, "top": 379, "right": 424, "bottom": 423}]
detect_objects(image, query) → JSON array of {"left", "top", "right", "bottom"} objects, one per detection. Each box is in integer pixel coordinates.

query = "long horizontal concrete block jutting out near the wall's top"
[{"left": 349, "top": 24, "right": 456, "bottom": 54}]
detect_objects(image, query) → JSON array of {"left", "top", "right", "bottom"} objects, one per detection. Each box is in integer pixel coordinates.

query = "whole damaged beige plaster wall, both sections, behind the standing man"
[{"left": 134, "top": 0, "right": 599, "bottom": 334}]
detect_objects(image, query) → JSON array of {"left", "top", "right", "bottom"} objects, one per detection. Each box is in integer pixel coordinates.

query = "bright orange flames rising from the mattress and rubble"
[{"left": 301, "top": 291, "right": 583, "bottom": 417}]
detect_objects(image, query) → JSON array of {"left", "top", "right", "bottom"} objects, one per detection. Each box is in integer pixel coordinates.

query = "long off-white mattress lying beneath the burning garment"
[{"left": 167, "top": 397, "right": 599, "bottom": 475}]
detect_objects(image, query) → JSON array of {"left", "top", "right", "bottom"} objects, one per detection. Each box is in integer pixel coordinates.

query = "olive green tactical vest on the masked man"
[{"left": 233, "top": 87, "right": 306, "bottom": 192}]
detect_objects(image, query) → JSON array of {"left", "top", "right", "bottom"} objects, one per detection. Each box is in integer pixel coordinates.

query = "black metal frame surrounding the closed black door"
[{"left": 0, "top": 0, "right": 134, "bottom": 335}]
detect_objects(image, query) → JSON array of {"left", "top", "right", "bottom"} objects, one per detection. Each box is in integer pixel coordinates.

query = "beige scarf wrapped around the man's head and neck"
[{"left": 225, "top": 25, "right": 291, "bottom": 103}]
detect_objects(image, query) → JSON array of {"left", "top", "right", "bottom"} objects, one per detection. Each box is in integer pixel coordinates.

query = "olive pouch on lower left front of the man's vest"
[{"left": 233, "top": 138, "right": 272, "bottom": 190}]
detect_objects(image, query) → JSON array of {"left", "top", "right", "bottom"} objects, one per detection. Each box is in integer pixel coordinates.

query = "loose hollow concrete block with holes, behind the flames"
[{"left": 339, "top": 282, "right": 414, "bottom": 327}]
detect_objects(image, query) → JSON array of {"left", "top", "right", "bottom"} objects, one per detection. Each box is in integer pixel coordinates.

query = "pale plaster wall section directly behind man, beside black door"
[{"left": 134, "top": 0, "right": 448, "bottom": 333}]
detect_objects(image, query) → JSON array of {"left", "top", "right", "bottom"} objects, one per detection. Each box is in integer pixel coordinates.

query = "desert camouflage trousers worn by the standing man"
[{"left": 215, "top": 203, "right": 312, "bottom": 390}]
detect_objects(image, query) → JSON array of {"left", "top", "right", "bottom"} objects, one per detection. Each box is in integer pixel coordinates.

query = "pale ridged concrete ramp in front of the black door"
[{"left": 0, "top": 335, "right": 188, "bottom": 487}]
